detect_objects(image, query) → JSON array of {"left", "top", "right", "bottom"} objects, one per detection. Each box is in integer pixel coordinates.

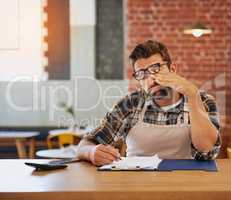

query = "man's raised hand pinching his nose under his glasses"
[{"left": 152, "top": 72, "right": 197, "bottom": 98}]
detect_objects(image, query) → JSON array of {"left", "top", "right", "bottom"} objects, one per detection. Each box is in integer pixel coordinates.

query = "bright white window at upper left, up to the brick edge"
[{"left": 0, "top": 0, "right": 44, "bottom": 81}]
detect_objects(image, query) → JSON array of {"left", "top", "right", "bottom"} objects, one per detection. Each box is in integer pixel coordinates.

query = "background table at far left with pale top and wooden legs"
[{"left": 0, "top": 131, "right": 39, "bottom": 159}]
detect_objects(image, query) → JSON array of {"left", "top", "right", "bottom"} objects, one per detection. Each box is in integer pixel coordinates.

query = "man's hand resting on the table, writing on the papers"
[{"left": 90, "top": 144, "right": 120, "bottom": 166}]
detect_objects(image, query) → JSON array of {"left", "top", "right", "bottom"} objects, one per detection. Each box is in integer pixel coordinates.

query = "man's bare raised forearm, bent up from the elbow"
[{"left": 188, "top": 93, "right": 217, "bottom": 151}]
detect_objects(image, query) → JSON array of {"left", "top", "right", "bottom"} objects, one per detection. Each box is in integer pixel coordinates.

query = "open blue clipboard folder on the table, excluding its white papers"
[{"left": 97, "top": 159, "right": 218, "bottom": 172}]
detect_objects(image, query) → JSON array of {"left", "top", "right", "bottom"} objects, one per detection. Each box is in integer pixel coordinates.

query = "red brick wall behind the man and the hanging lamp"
[{"left": 126, "top": 0, "right": 231, "bottom": 156}]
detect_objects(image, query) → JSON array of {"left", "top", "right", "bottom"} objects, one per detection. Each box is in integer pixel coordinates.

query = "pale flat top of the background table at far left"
[{"left": 0, "top": 131, "right": 39, "bottom": 138}]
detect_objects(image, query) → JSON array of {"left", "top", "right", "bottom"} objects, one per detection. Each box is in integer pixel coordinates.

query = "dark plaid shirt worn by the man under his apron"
[{"left": 85, "top": 90, "right": 221, "bottom": 160}]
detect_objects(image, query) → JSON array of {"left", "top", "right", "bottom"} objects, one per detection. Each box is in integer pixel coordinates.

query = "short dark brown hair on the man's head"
[{"left": 129, "top": 40, "right": 172, "bottom": 68}]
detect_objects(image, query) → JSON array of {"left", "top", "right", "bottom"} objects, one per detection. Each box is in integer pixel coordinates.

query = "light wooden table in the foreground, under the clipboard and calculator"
[{"left": 0, "top": 159, "right": 231, "bottom": 200}]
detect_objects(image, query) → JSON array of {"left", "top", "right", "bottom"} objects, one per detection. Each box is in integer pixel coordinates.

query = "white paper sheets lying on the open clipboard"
[{"left": 98, "top": 155, "right": 161, "bottom": 171}]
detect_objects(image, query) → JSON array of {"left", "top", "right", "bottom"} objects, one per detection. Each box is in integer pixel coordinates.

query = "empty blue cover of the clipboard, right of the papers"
[{"left": 157, "top": 159, "right": 218, "bottom": 172}]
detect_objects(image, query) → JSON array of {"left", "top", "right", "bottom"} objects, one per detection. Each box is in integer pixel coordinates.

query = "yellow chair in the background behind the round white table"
[{"left": 47, "top": 132, "right": 81, "bottom": 149}]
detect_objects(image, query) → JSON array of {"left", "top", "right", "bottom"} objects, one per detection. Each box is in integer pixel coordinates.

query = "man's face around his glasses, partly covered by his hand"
[{"left": 134, "top": 54, "right": 169, "bottom": 96}]
